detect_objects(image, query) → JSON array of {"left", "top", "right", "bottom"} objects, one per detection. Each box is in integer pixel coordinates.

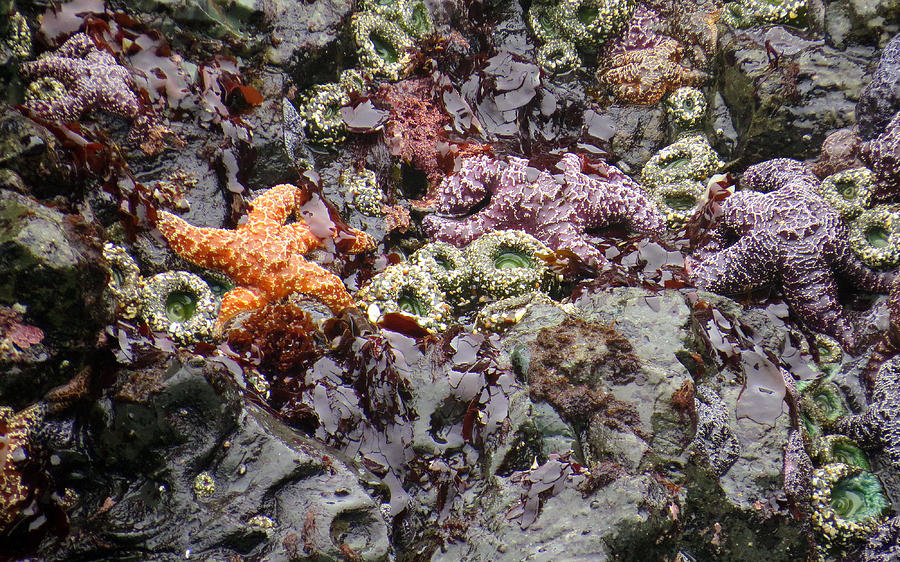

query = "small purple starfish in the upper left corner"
[{"left": 19, "top": 33, "right": 140, "bottom": 121}]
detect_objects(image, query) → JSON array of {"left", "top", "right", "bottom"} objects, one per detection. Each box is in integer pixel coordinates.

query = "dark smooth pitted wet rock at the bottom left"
[{"left": 36, "top": 358, "right": 389, "bottom": 561}]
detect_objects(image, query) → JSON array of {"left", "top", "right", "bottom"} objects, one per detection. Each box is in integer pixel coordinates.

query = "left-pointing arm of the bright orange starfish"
[{"left": 156, "top": 211, "right": 235, "bottom": 275}]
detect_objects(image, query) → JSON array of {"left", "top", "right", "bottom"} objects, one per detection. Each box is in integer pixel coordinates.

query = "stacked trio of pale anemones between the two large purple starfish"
[{"left": 641, "top": 87, "right": 723, "bottom": 228}]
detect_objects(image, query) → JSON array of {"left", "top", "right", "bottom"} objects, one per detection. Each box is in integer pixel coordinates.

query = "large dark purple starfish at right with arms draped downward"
[{"left": 686, "top": 158, "right": 894, "bottom": 350}]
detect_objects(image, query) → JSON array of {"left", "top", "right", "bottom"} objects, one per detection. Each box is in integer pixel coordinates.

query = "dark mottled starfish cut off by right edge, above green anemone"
[{"left": 835, "top": 358, "right": 900, "bottom": 468}]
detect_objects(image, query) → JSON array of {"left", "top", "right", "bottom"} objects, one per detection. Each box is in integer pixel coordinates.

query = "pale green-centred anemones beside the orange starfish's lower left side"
[{"left": 103, "top": 243, "right": 231, "bottom": 345}]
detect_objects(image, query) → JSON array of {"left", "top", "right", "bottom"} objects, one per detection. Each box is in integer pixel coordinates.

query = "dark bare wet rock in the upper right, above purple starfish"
[{"left": 719, "top": 26, "right": 872, "bottom": 164}]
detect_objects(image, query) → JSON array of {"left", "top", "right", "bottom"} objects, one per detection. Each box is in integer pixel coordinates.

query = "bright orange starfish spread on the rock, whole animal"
[{"left": 156, "top": 184, "right": 375, "bottom": 333}]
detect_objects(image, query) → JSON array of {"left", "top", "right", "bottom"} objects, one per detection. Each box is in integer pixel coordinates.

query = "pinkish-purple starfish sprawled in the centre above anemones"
[{"left": 423, "top": 153, "right": 665, "bottom": 265}]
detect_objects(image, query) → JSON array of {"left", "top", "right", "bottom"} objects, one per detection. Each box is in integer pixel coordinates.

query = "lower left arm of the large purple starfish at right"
[{"left": 691, "top": 236, "right": 776, "bottom": 295}]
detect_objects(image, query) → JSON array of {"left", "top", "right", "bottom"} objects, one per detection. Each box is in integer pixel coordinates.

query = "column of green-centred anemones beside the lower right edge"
[{"left": 797, "top": 370, "right": 889, "bottom": 555}]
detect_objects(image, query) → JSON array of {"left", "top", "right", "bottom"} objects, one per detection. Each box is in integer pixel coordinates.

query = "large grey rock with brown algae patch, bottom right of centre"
[{"left": 454, "top": 288, "right": 809, "bottom": 560}]
